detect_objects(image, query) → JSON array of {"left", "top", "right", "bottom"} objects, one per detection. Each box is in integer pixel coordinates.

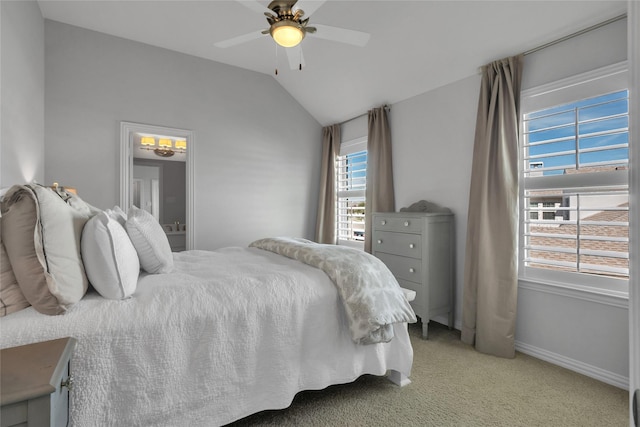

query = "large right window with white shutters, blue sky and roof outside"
[{"left": 520, "top": 64, "right": 629, "bottom": 292}]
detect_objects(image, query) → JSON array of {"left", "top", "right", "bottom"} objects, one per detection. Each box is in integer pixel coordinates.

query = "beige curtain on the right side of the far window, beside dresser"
[{"left": 364, "top": 106, "right": 395, "bottom": 253}]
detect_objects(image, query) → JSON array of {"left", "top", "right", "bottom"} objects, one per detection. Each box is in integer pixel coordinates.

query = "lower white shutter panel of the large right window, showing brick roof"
[{"left": 524, "top": 188, "right": 629, "bottom": 278}]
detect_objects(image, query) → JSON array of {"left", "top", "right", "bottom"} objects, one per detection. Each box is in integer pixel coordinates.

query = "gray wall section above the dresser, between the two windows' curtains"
[{"left": 390, "top": 76, "right": 480, "bottom": 328}]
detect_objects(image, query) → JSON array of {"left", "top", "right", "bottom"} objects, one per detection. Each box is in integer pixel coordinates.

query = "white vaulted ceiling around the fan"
[{"left": 39, "top": 0, "right": 626, "bottom": 125}]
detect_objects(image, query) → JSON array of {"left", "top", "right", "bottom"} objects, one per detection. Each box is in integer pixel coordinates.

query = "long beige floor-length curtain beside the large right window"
[{"left": 462, "top": 55, "right": 522, "bottom": 357}]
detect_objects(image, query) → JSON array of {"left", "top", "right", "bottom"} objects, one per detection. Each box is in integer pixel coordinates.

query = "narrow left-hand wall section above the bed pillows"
[{"left": 0, "top": 1, "right": 45, "bottom": 188}]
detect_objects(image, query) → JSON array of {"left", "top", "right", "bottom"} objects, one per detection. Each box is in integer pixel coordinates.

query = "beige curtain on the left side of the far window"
[{"left": 316, "top": 125, "right": 340, "bottom": 244}]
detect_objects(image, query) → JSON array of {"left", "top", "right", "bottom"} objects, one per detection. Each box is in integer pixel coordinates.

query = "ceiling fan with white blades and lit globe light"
[{"left": 214, "top": 0, "right": 370, "bottom": 74}]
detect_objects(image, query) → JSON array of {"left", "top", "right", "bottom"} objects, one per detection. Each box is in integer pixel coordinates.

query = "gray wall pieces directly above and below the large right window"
[{"left": 516, "top": 15, "right": 629, "bottom": 388}]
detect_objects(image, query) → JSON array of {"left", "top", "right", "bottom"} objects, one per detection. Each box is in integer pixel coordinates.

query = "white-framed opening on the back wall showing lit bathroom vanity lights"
[{"left": 120, "top": 122, "right": 195, "bottom": 252}]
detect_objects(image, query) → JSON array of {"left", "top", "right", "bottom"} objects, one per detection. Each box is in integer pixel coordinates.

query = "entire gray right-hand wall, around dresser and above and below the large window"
[{"left": 390, "top": 17, "right": 629, "bottom": 387}]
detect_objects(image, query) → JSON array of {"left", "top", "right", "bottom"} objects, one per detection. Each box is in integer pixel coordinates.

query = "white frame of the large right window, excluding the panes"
[{"left": 518, "top": 61, "right": 631, "bottom": 297}]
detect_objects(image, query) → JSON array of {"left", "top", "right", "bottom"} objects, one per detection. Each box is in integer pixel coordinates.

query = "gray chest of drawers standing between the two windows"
[{"left": 371, "top": 212, "right": 454, "bottom": 339}]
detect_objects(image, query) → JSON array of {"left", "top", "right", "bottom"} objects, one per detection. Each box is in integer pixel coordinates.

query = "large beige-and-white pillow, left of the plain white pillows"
[{"left": 2, "top": 185, "right": 93, "bottom": 314}]
